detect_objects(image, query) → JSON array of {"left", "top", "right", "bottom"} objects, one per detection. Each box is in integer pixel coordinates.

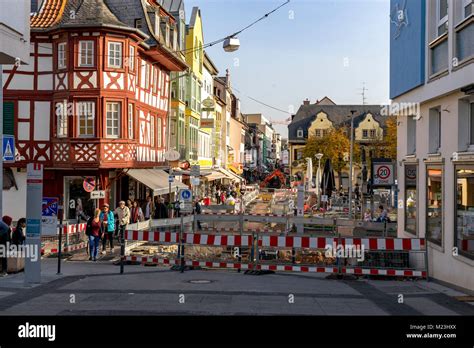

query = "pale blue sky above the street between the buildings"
[{"left": 185, "top": 0, "right": 390, "bottom": 137}]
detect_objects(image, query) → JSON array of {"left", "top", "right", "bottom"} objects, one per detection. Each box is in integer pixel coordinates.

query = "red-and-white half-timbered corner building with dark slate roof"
[{"left": 3, "top": 0, "right": 187, "bottom": 218}]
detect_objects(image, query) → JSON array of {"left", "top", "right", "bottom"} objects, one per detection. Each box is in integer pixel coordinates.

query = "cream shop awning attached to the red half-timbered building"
[{"left": 126, "top": 169, "right": 188, "bottom": 196}]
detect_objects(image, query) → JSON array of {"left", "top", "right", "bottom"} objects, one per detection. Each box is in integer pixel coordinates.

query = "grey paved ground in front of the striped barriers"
[{"left": 0, "top": 259, "right": 474, "bottom": 315}]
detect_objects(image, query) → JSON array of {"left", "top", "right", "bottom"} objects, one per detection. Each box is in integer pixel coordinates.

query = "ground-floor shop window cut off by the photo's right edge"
[{"left": 454, "top": 165, "right": 474, "bottom": 259}]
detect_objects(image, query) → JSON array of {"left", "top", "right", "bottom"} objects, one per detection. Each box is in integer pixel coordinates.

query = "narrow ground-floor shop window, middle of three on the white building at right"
[{"left": 426, "top": 166, "right": 443, "bottom": 245}]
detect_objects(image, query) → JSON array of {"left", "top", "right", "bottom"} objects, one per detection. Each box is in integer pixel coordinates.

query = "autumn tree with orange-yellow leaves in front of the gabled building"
[{"left": 303, "top": 126, "right": 360, "bottom": 186}]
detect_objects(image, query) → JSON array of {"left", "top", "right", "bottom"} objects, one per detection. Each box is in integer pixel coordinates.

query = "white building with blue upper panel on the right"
[{"left": 390, "top": 0, "right": 474, "bottom": 291}]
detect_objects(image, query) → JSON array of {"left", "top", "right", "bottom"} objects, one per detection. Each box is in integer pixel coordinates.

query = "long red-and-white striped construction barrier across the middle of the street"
[{"left": 120, "top": 214, "right": 427, "bottom": 278}]
